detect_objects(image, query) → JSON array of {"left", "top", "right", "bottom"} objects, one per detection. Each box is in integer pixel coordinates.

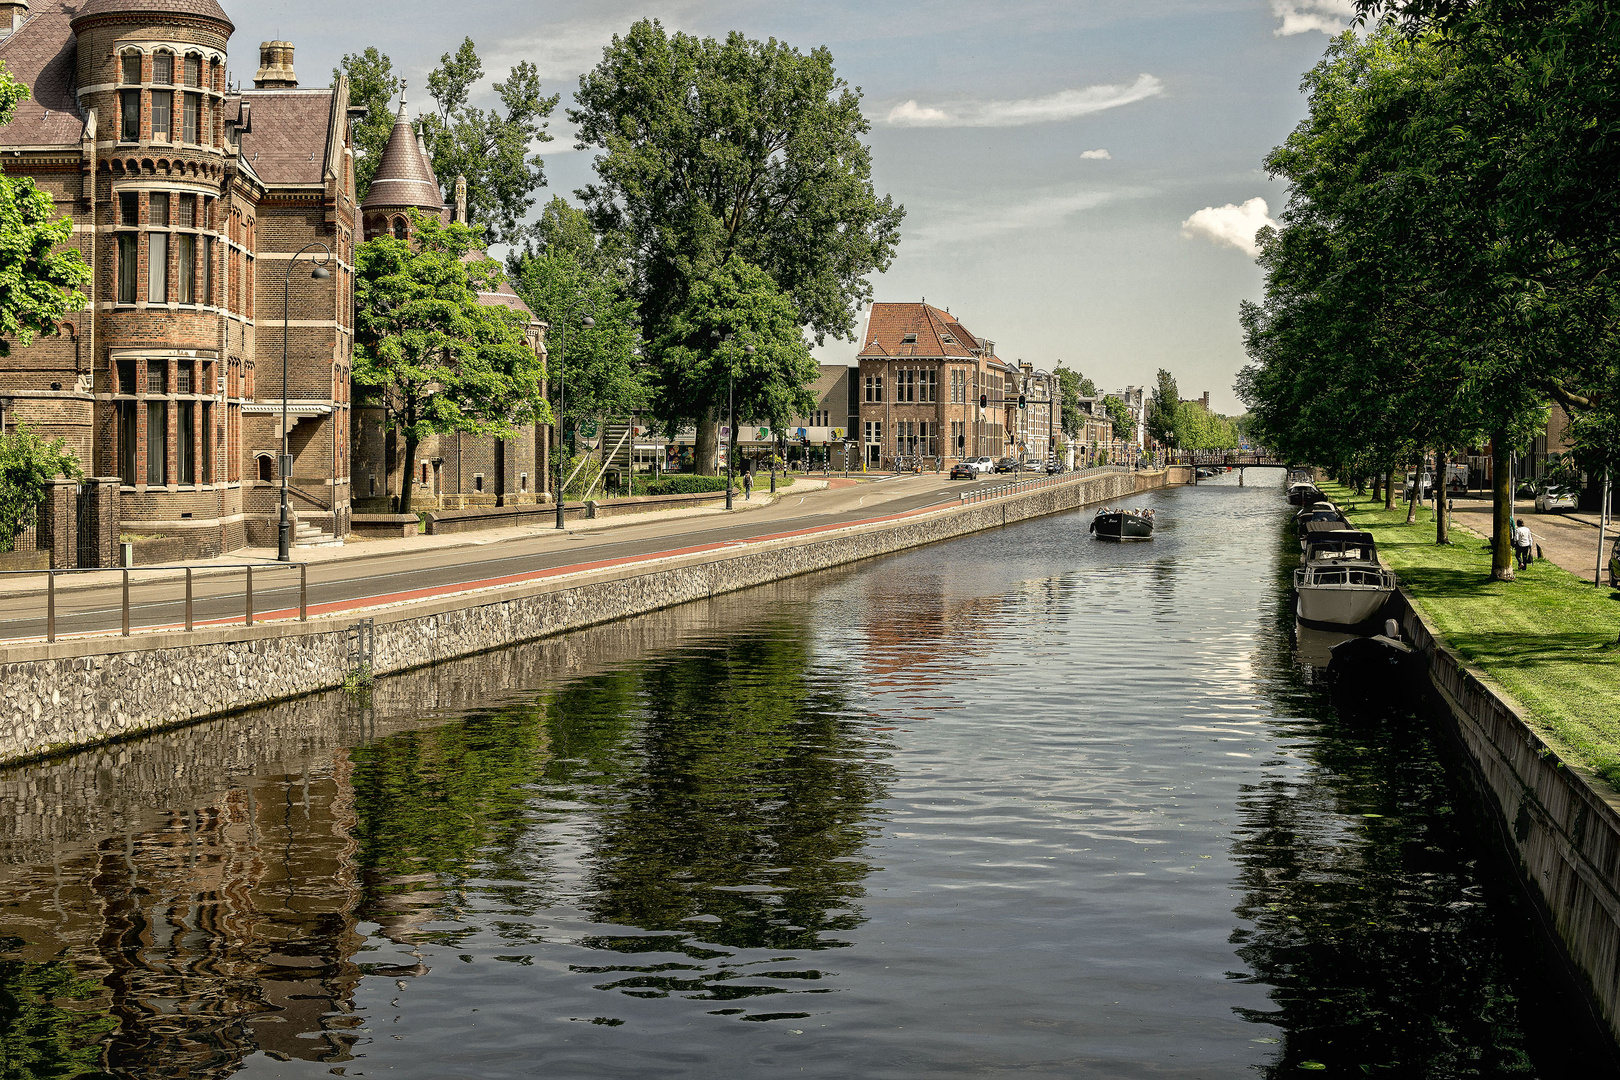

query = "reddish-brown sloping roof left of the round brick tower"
[{"left": 0, "top": 0, "right": 84, "bottom": 146}]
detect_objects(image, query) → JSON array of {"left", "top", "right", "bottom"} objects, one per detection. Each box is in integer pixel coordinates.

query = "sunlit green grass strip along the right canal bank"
[{"left": 1324, "top": 484, "right": 1620, "bottom": 789}]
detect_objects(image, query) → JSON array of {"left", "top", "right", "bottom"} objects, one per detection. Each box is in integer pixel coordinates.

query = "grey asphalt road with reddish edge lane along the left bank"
[{"left": 0, "top": 473, "right": 1062, "bottom": 640}]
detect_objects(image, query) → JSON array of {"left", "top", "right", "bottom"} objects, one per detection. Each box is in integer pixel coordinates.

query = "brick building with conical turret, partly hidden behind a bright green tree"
[{"left": 353, "top": 94, "right": 551, "bottom": 510}]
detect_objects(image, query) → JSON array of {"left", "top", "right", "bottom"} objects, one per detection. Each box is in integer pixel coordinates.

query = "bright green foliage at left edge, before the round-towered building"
[{"left": 0, "top": 63, "right": 91, "bottom": 356}]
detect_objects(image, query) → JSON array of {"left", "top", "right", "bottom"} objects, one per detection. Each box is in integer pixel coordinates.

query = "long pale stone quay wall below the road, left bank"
[{"left": 0, "top": 471, "right": 1166, "bottom": 763}]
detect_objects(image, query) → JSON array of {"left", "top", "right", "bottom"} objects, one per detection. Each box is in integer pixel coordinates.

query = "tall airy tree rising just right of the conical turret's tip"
[{"left": 421, "top": 37, "right": 557, "bottom": 243}]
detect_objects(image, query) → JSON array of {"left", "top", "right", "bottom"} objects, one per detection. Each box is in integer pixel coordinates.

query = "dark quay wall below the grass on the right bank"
[{"left": 1395, "top": 591, "right": 1620, "bottom": 1040}]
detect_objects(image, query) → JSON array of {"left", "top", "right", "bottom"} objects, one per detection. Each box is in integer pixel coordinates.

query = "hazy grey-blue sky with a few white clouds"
[{"left": 234, "top": 0, "right": 1351, "bottom": 413}]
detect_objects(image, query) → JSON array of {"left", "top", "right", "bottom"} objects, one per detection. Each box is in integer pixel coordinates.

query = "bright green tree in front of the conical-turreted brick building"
[{"left": 355, "top": 212, "right": 551, "bottom": 513}]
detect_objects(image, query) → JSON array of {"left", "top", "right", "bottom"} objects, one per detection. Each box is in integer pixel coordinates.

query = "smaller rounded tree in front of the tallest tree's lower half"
[{"left": 653, "top": 259, "right": 818, "bottom": 473}]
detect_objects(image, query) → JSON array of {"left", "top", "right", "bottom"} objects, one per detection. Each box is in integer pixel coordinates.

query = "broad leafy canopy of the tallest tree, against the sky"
[{"left": 569, "top": 19, "right": 904, "bottom": 343}]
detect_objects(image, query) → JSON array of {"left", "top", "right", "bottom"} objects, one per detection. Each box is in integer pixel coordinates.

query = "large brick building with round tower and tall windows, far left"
[{"left": 0, "top": 0, "right": 356, "bottom": 555}]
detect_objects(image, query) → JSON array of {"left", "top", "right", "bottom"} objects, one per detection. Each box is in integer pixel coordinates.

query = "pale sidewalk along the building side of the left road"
[{"left": 0, "top": 476, "right": 848, "bottom": 596}]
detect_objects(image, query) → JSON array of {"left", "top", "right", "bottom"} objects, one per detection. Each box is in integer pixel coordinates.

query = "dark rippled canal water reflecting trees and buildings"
[{"left": 0, "top": 473, "right": 1612, "bottom": 1080}]
